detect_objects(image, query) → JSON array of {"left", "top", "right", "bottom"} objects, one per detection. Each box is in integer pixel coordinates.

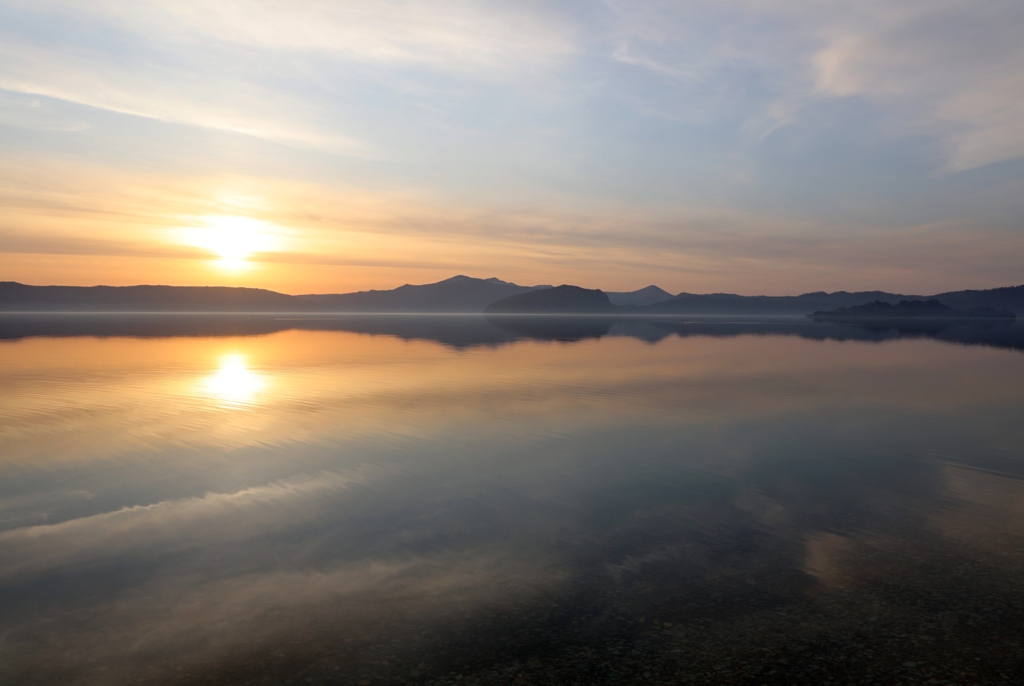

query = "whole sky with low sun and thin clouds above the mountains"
[{"left": 0, "top": 0, "right": 1024, "bottom": 295}]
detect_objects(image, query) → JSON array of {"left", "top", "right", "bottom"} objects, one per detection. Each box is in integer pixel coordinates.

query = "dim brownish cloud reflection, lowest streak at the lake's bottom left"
[{"left": 0, "top": 547, "right": 561, "bottom": 684}]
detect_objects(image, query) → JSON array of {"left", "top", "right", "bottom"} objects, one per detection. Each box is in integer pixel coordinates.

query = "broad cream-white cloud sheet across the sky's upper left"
[{"left": 0, "top": 0, "right": 572, "bottom": 149}]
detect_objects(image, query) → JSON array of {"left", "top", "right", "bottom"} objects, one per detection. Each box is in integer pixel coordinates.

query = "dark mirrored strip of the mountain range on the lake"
[{"left": 0, "top": 314, "right": 1024, "bottom": 350}]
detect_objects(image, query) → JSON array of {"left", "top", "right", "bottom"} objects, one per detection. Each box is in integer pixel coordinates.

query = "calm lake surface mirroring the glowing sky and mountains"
[{"left": 0, "top": 315, "right": 1024, "bottom": 686}]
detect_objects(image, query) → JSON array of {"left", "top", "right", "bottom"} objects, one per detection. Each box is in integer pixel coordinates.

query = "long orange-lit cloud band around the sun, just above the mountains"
[{"left": 0, "top": 154, "right": 1024, "bottom": 295}]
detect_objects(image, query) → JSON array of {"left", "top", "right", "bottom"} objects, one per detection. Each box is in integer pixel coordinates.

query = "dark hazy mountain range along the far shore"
[{"left": 0, "top": 275, "right": 1024, "bottom": 315}]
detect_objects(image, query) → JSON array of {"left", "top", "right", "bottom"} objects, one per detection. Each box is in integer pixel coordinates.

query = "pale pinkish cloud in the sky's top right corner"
[{"left": 814, "top": 2, "right": 1024, "bottom": 172}]
